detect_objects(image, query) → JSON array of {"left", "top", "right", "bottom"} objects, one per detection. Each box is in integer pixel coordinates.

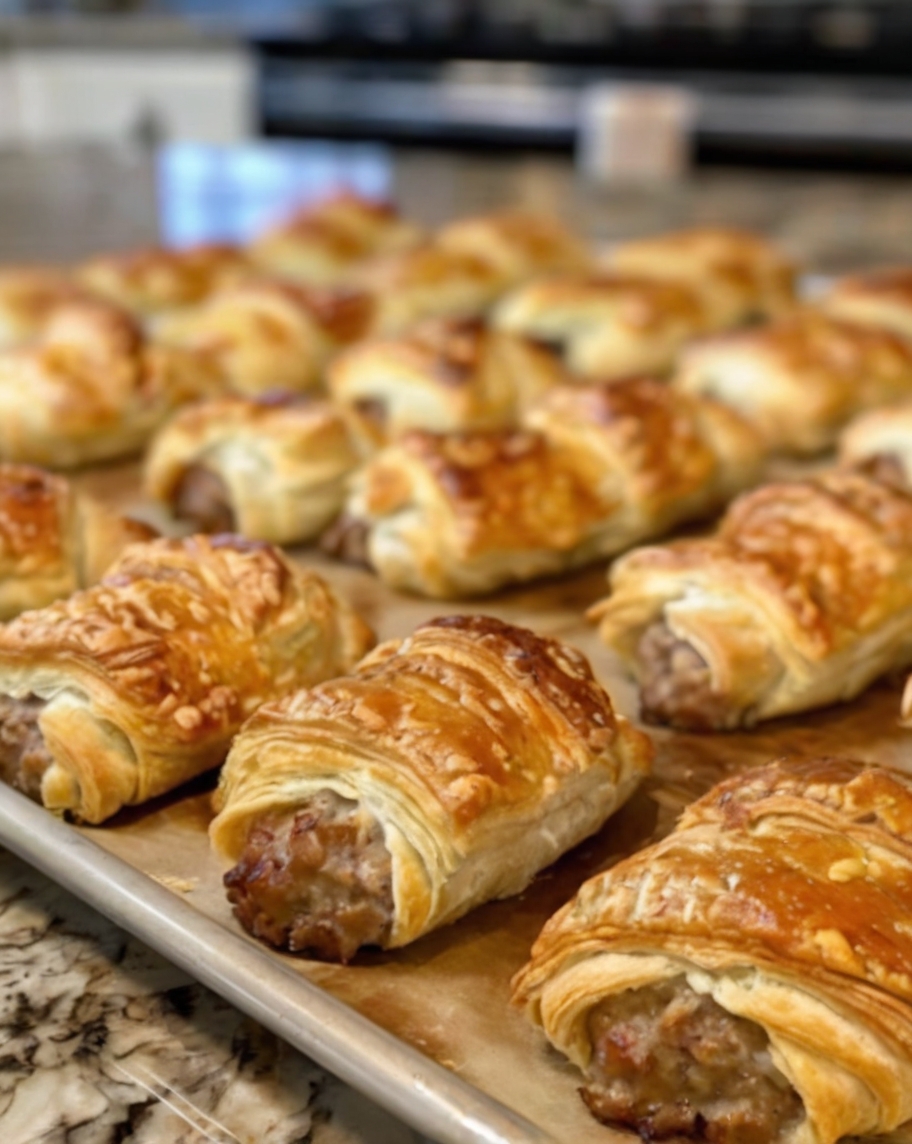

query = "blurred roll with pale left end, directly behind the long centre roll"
[{"left": 326, "top": 319, "right": 564, "bottom": 446}]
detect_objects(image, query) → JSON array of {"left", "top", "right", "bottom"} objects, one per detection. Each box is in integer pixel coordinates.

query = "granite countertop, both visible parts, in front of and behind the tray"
[{"left": 0, "top": 143, "right": 912, "bottom": 1144}]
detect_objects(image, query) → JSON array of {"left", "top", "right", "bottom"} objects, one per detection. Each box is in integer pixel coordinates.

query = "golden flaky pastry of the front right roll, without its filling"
[{"left": 514, "top": 758, "right": 912, "bottom": 1144}]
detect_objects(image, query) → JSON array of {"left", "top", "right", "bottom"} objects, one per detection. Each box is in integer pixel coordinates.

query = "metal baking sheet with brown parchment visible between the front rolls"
[{"left": 0, "top": 467, "right": 912, "bottom": 1144}]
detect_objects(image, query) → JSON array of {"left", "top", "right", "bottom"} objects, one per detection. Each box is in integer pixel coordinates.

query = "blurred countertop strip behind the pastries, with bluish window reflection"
[{"left": 0, "top": 142, "right": 912, "bottom": 275}]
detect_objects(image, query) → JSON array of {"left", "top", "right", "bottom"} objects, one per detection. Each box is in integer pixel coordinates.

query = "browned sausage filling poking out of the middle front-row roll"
[{"left": 224, "top": 791, "right": 392, "bottom": 962}]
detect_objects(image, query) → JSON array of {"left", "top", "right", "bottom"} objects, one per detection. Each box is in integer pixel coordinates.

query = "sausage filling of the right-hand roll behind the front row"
[{"left": 636, "top": 621, "right": 731, "bottom": 731}]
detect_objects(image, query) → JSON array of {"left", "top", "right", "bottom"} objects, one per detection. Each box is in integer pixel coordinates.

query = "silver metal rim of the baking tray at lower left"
[{"left": 0, "top": 784, "right": 558, "bottom": 1144}]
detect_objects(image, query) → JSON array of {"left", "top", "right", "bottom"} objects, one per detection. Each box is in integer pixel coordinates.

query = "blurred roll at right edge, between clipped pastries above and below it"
[{"left": 674, "top": 310, "right": 912, "bottom": 453}]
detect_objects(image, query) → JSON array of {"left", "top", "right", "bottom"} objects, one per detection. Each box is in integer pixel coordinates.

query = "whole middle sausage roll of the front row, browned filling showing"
[{"left": 211, "top": 615, "right": 651, "bottom": 961}]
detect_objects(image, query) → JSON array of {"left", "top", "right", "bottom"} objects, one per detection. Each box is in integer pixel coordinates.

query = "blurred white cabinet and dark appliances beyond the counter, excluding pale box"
[{"left": 0, "top": 0, "right": 912, "bottom": 168}]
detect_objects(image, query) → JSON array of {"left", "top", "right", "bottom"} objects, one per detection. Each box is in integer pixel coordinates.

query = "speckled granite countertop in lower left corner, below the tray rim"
[{"left": 0, "top": 851, "right": 423, "bottom": 1144}]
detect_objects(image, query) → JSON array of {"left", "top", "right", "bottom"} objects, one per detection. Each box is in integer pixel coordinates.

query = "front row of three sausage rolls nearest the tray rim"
[{"left": 0, "top": 519, "right": 912, "bottom": 1144}]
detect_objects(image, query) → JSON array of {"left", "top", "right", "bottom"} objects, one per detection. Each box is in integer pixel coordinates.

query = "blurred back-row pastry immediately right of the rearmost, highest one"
[{"left": 437, "top": 209, "right": 593, "bottom": 285}]
